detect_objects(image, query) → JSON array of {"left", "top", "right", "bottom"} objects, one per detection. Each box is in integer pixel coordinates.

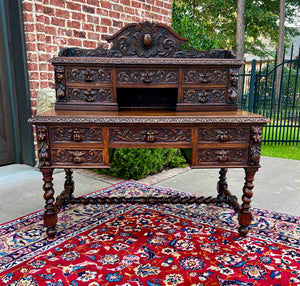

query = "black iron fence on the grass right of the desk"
[{"left": 239, "top": 47, "right": 300, "bottom": 145}]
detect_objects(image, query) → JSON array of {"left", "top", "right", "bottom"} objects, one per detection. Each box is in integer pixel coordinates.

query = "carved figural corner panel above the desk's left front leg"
[{"left": 36, "top": 125, "right": 51, "bottom": 167}]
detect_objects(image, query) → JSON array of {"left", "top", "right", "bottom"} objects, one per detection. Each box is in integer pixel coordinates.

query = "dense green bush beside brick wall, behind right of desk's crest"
[{"left": 172, "top": 1, "right": 219, "bottom": 50}]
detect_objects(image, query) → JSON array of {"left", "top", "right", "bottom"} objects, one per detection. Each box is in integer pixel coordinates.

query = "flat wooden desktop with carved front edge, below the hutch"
[{"left": 29, "top": 110, "right": 268, "bottom": 124}]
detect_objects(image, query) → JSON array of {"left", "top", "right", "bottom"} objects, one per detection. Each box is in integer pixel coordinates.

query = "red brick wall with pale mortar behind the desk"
[{"left": 23, "top": 0, "right": 172, "bottom": 114}]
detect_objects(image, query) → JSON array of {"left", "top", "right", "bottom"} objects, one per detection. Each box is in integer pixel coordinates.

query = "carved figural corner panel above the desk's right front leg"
[{"left": 249, "top": 126, "right": 263, "bottom": 166}]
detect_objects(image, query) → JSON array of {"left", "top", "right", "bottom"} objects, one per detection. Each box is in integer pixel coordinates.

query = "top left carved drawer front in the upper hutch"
[{"left": 66, "top": 67, "right": 112, "bottom": 83}]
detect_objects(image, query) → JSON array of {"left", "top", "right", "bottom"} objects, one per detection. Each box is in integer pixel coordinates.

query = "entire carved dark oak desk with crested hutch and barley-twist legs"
[{"left": 29, "top": 22, "right": 266, "bottom": 238}]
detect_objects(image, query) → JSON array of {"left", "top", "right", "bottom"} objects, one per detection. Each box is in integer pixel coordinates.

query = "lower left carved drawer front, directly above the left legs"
[{"left": 51, "top": 147, "right": 104, "bottom": 165}]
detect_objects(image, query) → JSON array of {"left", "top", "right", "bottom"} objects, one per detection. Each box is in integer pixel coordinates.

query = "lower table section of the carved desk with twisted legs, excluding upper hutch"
[{"left": 30, "top": 111, "right": 266, "bottom": 237}]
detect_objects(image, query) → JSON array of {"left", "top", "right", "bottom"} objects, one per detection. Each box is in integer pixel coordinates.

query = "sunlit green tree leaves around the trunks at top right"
[{"left": 173, "top": 0, "right": 300, "bottom": 56}]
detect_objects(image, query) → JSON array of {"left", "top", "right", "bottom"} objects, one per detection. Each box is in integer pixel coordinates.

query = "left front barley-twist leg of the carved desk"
[{"left": 41, "top": 168, "right": 57, "bottom": 238}]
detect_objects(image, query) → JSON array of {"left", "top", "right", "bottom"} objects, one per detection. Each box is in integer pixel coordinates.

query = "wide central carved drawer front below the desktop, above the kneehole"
[{"left": 109, "top": 128, "right": 192, "bottom": 143}]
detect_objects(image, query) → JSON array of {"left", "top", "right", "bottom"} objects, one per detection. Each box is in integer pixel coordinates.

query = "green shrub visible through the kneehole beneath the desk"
[{"left": 95, "top": 149, "right": 186, "bottom": 180}]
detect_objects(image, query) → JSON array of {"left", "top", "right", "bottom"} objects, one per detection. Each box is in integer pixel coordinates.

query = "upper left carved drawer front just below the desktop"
[{"left": 50, "top": 126, "right": 103, "bottom": 143}]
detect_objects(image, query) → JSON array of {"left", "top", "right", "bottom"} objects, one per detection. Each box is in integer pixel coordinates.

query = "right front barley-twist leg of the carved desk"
[{"left": 238, "top": 167, "right": 258, "bottom": 237}]
